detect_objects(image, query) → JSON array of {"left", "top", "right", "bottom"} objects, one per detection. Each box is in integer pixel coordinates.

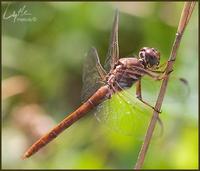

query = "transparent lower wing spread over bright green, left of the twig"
[{"left": 95, "top": 86, "right": 152, "bottom": 138}]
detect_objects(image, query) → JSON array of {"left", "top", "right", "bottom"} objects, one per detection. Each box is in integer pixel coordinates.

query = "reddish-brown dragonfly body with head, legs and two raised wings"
[{"left": 23, "top": 10, "right": 172, "bottom": 159}]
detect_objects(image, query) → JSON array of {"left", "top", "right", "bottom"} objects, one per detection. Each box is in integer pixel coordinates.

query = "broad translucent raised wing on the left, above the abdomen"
[{"left": 81, "top": 47, "right": 106, "bottom": 101}]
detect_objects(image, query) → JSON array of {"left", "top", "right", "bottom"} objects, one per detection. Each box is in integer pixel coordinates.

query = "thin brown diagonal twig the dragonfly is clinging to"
[{"left": 135, "top": 2, "right": 195, "bottom": 169}]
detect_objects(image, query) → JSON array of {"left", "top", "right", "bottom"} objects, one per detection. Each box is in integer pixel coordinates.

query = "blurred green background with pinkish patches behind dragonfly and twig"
[{"left": 2, "top": 2, "right": 198, "bottom": 169}]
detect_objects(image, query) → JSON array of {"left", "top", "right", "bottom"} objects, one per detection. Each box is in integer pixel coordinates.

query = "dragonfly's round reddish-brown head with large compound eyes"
[{"left": 139, "top": 47, "right": 160, "bottom": 69}]
